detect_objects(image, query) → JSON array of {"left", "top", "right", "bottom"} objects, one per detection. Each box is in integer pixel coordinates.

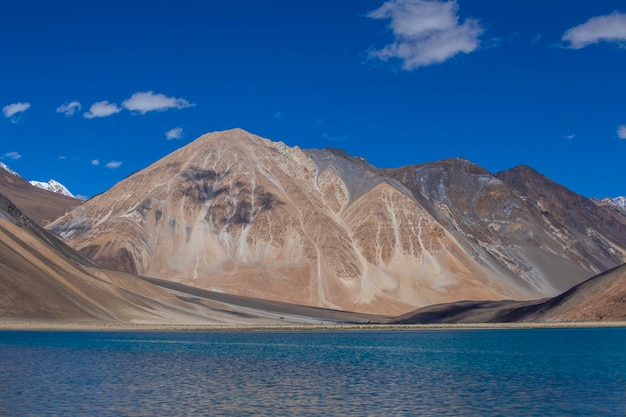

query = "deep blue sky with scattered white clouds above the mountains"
[{"left": 0, "top": 0, "right": 626, "bottom": 198}]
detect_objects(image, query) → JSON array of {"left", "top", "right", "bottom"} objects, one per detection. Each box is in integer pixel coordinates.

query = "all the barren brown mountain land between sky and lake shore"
[{"left": 0, "top": 129, "right": 626, "bottom": 325}]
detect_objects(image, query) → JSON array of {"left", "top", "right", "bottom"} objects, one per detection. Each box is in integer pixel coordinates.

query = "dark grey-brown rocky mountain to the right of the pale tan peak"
[{"left": 386, "top": 159, "right": 626, "bottom": 297}]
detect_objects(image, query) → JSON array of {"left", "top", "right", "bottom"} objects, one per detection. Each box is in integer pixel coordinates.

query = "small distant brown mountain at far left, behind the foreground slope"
[{"left": 0, "top": 164, "right": 82, "bottom": 226}]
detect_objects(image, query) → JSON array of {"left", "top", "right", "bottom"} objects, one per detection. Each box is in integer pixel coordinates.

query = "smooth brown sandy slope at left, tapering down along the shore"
[{"left": 0, "top": 195, "right": 386, "bottom": 325}]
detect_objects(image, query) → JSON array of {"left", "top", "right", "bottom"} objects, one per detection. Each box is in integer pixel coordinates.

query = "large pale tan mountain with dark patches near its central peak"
[{"left": 51, "top": 129, "right": 543, "bottom": 314}]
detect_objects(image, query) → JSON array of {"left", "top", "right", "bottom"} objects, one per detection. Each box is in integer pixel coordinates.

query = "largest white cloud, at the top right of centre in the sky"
[{"left": 368, "top": 0, "right": 483, "bottom": 71}]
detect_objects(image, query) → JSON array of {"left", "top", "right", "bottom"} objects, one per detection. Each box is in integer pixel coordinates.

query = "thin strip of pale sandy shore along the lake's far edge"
[{"left": 0, "top": 319, "right": 626, "bottom": 331}]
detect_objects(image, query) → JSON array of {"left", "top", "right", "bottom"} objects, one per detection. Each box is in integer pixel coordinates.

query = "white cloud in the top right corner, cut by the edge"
[{"left": 562, "top": 11, "right": 626, "bottom": 49}]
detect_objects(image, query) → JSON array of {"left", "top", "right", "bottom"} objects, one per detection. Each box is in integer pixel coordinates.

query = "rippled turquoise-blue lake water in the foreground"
[{"left": 0, "top": 328, "right": 626, "bottom": 416}]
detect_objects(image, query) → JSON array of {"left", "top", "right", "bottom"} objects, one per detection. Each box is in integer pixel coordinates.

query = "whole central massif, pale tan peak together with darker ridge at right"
[{"left": 49, "top": 129, "right": 626, "bottom": 315}]
